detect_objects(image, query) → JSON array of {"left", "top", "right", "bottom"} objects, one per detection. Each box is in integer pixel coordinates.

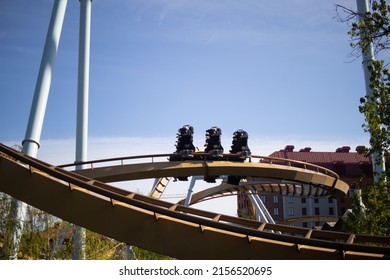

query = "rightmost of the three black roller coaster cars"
[{"left": 227, "top": 129, "right": 251, "bottom": 186}]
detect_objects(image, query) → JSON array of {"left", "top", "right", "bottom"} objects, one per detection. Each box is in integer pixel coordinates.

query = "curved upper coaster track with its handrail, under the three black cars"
[{"left": 60, "top": 152, "right": 349, "bottom": 197}]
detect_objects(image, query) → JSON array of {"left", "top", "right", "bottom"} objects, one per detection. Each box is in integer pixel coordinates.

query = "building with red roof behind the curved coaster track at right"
[{"left": 237, "top": 145, "right": 373, "bottom": 227}]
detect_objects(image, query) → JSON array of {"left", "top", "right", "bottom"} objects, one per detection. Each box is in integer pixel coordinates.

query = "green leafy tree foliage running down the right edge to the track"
[{"left": 337, "top": 0, "right": 390, "bottom": 236}]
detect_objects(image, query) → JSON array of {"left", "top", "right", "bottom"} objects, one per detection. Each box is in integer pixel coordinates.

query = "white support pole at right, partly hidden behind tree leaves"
[{"left": 356, "top": 0, "right": 386, "bottom": 182}]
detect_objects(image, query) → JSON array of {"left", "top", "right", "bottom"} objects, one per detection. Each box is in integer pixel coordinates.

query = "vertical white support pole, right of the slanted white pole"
[{"left": 72, "top": 0, "right": 92, "bottom": 259}]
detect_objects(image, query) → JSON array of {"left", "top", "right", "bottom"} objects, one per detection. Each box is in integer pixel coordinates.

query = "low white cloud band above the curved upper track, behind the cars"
[{"left": 4, "top": 135, "right": 368, "bottom": 165}]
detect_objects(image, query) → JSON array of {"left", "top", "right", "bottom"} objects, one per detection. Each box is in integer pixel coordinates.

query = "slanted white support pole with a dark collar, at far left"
[{"left": 4, "top": 0, "right": 68, "bottom": 259}]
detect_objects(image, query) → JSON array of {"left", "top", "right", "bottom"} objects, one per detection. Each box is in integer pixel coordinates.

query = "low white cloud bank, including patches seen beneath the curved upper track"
[{"left": 5, "top": 132, "right": 367, "bottom": 216}]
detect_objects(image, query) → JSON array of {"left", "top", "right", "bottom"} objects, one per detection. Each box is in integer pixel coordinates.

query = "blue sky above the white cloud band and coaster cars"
[{"left": 0, "top": 0, "right": 367, "bottom": 153}]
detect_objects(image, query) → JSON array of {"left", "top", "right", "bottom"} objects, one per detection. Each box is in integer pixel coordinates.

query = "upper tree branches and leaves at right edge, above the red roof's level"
[{"left": 336, "top": 0, "right": 390, "bottom": 166}]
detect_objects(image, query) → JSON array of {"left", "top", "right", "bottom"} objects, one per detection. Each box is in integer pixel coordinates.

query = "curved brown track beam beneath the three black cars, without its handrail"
[{"left": 74, "top": 158, "right": 349, "bottom": 197}]
